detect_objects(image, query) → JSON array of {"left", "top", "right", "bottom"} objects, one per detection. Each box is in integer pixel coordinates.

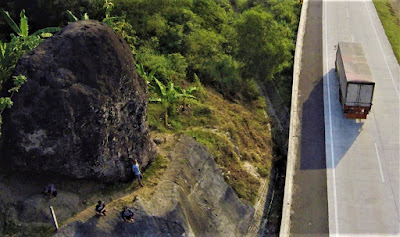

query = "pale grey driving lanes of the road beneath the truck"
[{"left": 321, "top": 0, "right": 400, "bottom": 236}]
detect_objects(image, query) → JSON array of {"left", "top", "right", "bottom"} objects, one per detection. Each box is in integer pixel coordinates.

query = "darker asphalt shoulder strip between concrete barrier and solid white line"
[{"left": 290, "top": 0, "right": 329, "bottom": 236}]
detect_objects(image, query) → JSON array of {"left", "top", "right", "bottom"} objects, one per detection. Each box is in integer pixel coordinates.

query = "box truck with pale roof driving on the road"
[{"left": 335, "top": 42, "right": 375, "bottom": 119}]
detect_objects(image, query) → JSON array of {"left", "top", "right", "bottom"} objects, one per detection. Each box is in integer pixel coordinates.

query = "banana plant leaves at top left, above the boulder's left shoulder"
[{"left": 1, "top": 9, "right": 61, "bottom": 38}]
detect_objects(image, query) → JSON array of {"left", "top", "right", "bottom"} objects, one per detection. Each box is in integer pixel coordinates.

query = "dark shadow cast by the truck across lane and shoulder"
[{"left": 300, "top": 69, "right": 363, "bottom": 170}]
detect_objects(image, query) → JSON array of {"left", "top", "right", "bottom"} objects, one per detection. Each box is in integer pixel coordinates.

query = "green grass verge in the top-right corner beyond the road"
[{"left": 373, "top": 0, "right": 400, "bottom": 63}]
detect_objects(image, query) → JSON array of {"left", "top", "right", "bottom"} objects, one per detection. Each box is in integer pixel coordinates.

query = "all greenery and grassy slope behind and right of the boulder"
[{"left": 0, "top": 0, "right": 300, "bottom": 203}]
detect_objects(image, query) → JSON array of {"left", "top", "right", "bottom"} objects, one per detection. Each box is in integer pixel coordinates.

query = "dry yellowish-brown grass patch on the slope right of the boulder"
[{"left": 148, "top": 89, "right": 273, "bottom": 204}]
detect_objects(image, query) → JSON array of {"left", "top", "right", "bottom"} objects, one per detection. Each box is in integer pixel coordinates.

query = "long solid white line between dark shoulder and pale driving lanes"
[{"left": 324, "top": 2, "right": 339, "bottom": 236}]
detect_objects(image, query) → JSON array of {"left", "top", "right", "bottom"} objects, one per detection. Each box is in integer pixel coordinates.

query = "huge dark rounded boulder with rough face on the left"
[{"left": 0, "top": 20, "right": 155, "bottom": 182}]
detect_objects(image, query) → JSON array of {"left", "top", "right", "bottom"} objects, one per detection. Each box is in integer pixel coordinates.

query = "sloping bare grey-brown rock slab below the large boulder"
[{"left": 56, "top": 136, "right": 254, "bottom": 237}]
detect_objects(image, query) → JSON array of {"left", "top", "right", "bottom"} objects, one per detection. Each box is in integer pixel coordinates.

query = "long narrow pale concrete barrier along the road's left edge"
[{"left": 279, "top": 0, "right": 309, "bottom": 237}]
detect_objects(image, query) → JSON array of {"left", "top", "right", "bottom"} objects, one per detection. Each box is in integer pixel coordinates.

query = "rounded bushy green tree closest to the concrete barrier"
[{"left": 236, "top": 7, "right": 293, "bottom": 81}]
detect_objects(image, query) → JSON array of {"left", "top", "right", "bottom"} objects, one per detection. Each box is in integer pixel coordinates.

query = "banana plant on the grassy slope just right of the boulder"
[{"left": 150, "top": 78, "right": 197, "bottom": 127}]
